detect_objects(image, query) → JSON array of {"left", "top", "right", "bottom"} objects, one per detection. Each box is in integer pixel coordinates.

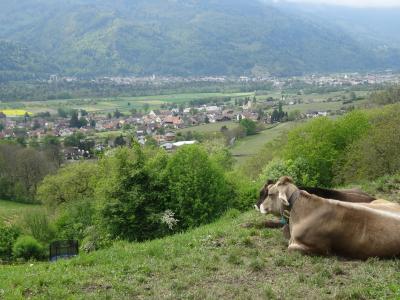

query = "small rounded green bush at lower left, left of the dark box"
[{"left": 12, "top": 235, "right": 44, "bottom": 260}]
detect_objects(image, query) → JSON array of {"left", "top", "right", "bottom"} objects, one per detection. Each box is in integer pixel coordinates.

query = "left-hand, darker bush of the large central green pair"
[{"left": 96, "top": 145, "right": 168, "bottom": 241}]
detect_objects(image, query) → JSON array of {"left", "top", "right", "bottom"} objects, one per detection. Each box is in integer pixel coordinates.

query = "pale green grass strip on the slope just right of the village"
[{"left": 231, "top": 122, "right": 296, "bottom": 165}]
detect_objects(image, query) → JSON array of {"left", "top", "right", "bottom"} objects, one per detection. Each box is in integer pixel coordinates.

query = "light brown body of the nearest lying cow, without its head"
[{"left": 289, "top": 194, "right": 400, "bottom": 258}]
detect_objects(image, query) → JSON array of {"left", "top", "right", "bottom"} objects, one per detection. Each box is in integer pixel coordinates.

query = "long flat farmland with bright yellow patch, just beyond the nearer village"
[{"left": 0, "top": 93, "right": 254, "bottom": 113}]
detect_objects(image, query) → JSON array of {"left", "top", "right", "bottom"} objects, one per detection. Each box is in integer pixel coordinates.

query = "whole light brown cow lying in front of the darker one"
[{"left": 261, "top": 177, "right": 400, "bottom": 259}]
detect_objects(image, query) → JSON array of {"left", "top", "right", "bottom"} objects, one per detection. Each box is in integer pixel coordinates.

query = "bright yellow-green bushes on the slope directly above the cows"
[{"left": 284, "top": 111, "right": 370, "bottom": 186}]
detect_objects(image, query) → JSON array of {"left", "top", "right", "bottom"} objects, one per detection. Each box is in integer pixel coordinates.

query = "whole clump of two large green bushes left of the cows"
[{"left": 96, "top": 145, "right": 233, "bottom": 241}]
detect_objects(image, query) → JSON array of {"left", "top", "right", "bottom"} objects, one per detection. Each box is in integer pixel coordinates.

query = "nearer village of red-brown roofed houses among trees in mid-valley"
[{"left": 0, "top": 92, "right": 336, "bottom": 160}]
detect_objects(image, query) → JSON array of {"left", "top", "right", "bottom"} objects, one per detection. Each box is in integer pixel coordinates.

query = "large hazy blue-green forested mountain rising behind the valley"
[{"left": 0, "top": 0, "right": 400, "bottom": 76}]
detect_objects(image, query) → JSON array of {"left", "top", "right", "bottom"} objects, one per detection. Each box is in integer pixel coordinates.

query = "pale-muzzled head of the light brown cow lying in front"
[{"left": 260, "top": 176, "right": 298, "bottom": 217}]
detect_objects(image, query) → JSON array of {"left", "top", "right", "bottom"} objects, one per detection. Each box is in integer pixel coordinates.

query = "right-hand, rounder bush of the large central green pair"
[{"left": 164, "top": 145, "right": 232, "bottom": 229}]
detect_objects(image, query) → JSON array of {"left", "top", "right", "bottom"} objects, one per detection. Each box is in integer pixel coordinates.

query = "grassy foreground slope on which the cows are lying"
[{"left": 0, "top": 212, "right": 400, "bottom": 299}]
